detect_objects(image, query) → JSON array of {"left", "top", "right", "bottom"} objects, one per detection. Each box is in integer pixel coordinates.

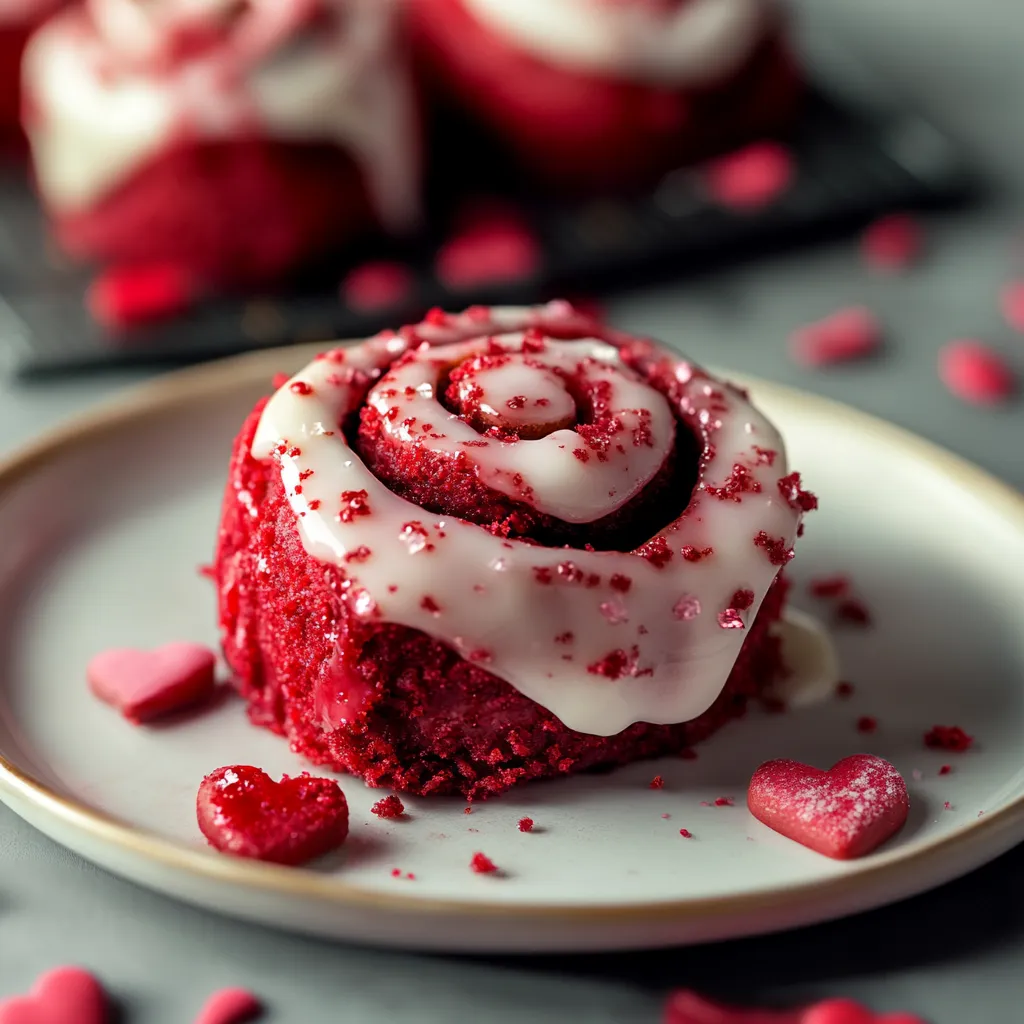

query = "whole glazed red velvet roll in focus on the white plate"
[{"left": 216, "top": 303, "right": 816, "bottom": 798}]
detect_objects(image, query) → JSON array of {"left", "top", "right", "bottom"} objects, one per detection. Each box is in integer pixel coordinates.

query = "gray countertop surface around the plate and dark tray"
[{"left": 0, "top": 0, "right": 1024, "bottom": 1024}]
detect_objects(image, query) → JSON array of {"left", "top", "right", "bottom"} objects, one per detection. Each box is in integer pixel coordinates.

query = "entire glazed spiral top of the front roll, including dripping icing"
[{"left": 253, "top": 303, "right": 815, "bottom": 735}]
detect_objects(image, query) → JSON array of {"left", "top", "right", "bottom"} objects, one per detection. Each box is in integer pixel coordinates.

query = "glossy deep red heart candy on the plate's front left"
[{"left": 196, "top": 765, "right": 348, "bottom": 864}]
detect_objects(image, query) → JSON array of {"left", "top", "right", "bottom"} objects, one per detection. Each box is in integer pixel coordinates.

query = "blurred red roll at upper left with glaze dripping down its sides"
[{"left": 25, "top": 0, "right": 419, "bottom": 285}]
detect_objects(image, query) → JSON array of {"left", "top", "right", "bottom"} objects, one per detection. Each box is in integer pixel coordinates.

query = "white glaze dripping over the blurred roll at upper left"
[{"left": 23, "top": 0, "right": 419, "bottom": 230}]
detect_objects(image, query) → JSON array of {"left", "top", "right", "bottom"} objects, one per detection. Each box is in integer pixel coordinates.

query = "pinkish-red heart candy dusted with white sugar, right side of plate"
[{"left": 746, "top": 754, "right": 910, "bottom": 860}]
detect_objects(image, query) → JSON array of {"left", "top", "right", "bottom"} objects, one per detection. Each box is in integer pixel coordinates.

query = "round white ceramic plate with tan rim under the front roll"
[{"left": 0, "top": 350, "right": 1024, "bottom": 951}]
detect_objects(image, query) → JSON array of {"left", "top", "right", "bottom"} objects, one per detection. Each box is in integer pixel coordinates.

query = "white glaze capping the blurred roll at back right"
[{"left": 458, "top": 0, "right": 768, "bottom": 86}]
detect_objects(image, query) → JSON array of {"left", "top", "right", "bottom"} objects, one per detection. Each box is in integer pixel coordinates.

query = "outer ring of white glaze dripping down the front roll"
[{"left": 252, "top": 303, "right": 801, "bottom": 735}]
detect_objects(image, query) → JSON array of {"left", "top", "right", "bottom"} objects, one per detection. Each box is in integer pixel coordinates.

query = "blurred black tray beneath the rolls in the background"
[{"left": 0, "top": 93, "right": 972, "bottom": 376}]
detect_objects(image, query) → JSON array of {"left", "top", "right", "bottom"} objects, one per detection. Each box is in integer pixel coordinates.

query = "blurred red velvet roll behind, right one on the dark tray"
[{"left": 410, "top": 0, "right": 801, "bottom": 187}]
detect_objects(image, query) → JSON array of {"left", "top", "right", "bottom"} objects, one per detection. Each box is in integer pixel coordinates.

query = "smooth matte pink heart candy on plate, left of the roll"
[{"left": 86, "top": 642, "right": 216, "bottom": 724}]
